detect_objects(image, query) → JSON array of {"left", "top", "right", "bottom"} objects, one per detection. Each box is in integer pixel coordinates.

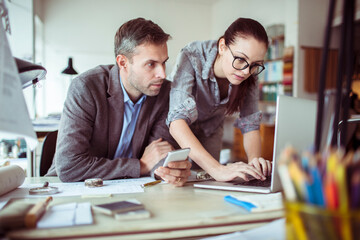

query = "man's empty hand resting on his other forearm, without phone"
[{"left": 140, "top": 138, "right": 174, "bottom": 175}]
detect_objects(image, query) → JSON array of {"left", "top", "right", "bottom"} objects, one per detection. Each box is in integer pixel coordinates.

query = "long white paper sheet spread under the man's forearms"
[{"left": 0, "top": 177, "right": 155, "bottom": 202}]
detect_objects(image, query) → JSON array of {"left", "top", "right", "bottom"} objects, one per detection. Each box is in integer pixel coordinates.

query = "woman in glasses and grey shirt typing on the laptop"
[{"left": 167, "top": 18, "right": 271, "bottom": 181}]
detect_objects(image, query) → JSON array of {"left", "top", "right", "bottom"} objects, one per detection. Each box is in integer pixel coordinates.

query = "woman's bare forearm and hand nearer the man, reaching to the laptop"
[{"left": 170, "top": 119, "right": 265, "bottom": 181}]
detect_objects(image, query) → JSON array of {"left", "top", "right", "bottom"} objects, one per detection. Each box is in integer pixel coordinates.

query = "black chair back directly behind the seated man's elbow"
[{"left": 40, "top": 131, "right": 58, "bottom": 176}]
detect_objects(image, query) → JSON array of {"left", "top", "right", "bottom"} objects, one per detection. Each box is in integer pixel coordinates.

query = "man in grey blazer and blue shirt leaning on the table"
[{"left": 47, "top": 18, "right": 191, "bottom": 186}]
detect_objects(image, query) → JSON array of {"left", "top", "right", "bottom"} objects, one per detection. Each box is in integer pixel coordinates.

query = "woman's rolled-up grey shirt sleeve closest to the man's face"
[{"left": 166, "top": 51, "right": 198, "bottom": 126}]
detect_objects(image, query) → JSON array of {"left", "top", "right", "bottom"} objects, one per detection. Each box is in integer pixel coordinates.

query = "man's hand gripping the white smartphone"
[{"left": 155, "top": 160, "right": 191, "bottom": 187}]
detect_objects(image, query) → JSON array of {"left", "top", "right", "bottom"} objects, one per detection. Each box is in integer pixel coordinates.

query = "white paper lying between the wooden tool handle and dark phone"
[{"left": 37, "top": 202, "right": 93, "bottom": 228}]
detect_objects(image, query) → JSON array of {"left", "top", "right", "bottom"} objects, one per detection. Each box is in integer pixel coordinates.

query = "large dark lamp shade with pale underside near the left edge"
[{"left": 15, "top": 58, "right": 46, "bottom": 88}]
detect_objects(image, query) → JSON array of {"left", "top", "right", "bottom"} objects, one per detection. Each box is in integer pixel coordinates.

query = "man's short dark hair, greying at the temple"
[{"left": 114, "top": 18, "right": 170, "bottom": 60}]
